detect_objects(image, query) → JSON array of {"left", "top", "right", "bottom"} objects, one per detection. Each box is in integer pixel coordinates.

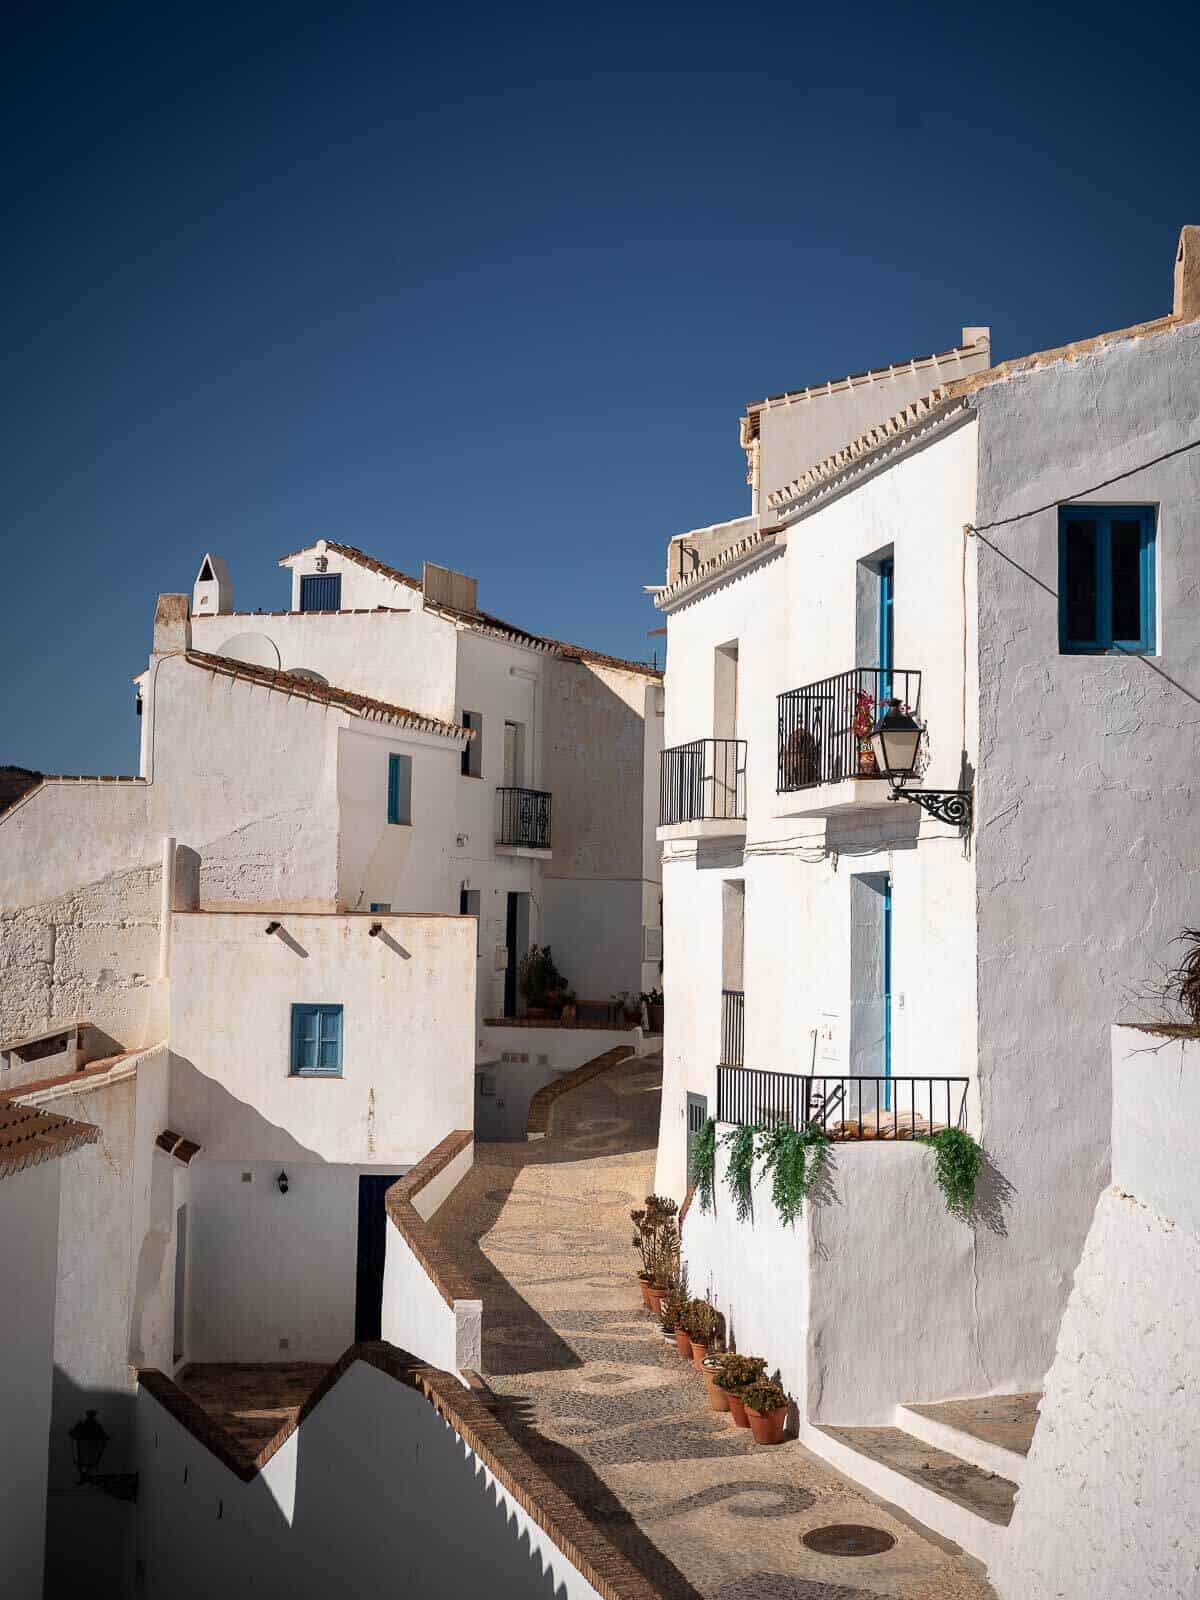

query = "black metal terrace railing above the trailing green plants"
[{"left": 717, "top": 1066, "right": 968, "bottom": 1139}]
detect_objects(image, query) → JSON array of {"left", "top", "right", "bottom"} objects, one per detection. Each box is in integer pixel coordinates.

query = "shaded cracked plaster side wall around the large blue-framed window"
[{"left": 974, "top": 325, "right": 1200, "bottom": 1389}]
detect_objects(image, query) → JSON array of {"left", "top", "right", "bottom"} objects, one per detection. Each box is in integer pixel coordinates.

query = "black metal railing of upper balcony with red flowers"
[{"left": 776, "top": 667, "right": 922, "bottom": 794}]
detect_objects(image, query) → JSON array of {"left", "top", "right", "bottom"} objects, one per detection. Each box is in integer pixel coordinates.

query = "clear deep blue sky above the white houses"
[{"left": 0, "top": 0, "right": 1200, "bottom": 773}]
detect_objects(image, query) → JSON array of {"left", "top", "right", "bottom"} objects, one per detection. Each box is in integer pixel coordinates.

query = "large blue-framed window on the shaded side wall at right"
[{"left": 1058, "top": 506, "right": 1155, "bottom": 656}]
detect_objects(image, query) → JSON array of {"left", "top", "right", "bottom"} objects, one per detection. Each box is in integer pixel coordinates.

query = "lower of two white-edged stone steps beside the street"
[{"left": 808, "top": 1424, "right": 1016, "bottom": 1562}]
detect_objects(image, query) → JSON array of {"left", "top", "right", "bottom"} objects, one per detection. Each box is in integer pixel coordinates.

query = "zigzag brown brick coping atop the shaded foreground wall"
[{"left": 138, "top": 1339, "right": 664, "bottom": 1600}]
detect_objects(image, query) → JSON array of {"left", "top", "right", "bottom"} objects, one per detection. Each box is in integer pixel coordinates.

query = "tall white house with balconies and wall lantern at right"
[{"left": 656, "top": 229, "right": 1200, "bottom": 1555}]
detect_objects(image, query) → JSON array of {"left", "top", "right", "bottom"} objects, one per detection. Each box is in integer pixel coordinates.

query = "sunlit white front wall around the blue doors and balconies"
[{"left": 656, "top": 426, "right": 978, "bottom": 1197}]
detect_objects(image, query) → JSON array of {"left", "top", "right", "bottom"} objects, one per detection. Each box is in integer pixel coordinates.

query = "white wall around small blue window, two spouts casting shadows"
[{"left": 171, "top": 912, "right": 475, "bottom": 1166}]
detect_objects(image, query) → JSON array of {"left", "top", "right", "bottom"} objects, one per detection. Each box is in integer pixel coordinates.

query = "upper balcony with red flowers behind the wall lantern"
[{"left": 776, "top": 667, "right": 922, "bottom": 816}]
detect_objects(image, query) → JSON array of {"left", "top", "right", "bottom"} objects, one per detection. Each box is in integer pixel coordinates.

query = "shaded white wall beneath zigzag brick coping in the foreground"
[{"left": 138, "top": 1362, "right": 614, "bottom": 1600}]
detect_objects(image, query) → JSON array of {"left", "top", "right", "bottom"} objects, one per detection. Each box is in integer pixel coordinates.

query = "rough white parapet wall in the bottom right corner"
[{"left": 990, "top": 1027, "right": 1200, "bottom": 1600}]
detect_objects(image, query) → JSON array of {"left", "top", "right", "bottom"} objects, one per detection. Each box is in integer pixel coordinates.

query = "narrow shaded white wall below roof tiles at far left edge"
[{"left": 0, "top": 1157, "right": 61, "bottom": 1600}]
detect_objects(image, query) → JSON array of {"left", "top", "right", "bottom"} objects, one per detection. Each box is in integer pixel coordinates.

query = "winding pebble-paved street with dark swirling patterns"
[{"left": 434, "top": 1058, "right": 992, "bottom": 1600}]
